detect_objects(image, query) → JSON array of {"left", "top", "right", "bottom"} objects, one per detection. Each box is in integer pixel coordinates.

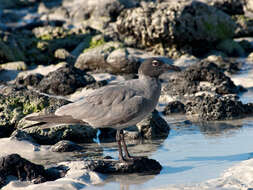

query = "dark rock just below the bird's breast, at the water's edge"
[{"left": 136, "top": 110, "right": 170, "bottom": 139}]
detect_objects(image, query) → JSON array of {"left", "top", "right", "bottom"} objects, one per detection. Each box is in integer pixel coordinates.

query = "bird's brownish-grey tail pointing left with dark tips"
[{"left": 23, "top": 114, "right": 88, "bottom": 129}]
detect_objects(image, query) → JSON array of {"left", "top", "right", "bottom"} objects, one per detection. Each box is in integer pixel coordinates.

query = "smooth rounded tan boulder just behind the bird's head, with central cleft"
[{"left": 75, "top": 42, "right": 171, "bottom": 74}]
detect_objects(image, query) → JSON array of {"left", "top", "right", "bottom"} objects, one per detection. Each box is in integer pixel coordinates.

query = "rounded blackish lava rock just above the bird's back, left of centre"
[{"left": 36, "top": 65, "right": 95, "bottom": 95}]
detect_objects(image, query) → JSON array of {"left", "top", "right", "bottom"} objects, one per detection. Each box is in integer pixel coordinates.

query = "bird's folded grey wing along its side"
[{"left": 55, "top": 85, "right": 147, "bottom": 127}]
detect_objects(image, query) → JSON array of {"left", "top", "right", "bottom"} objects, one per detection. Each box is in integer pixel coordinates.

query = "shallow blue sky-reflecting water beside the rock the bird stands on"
[{"left": 81, "top": 117, "right": 253, "bottom": 190}]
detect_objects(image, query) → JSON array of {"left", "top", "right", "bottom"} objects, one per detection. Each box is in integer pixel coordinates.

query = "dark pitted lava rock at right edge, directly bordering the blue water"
[{"left": 185, "top": 95, "right": 253, "bottom": 120}]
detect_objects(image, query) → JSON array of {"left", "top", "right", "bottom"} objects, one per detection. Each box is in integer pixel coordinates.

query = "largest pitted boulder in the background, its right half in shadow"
[{"left": 116, "top": 1, "right": 236, "bottom": 55}]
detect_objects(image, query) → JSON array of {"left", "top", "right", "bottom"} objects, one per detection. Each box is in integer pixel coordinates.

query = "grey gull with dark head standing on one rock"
[{"left": 26, "top": 58, "right": 180, "bottom": 161}]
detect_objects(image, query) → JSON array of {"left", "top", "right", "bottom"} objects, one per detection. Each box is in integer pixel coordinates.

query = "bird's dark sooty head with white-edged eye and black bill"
[{"left": 138, "top": 58, "right": 181, "bottom": 78}]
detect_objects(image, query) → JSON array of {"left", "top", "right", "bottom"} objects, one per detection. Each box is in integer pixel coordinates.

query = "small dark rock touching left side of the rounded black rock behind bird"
[{"left": 16, "top": 73, "right": 44, "bottom": 86}]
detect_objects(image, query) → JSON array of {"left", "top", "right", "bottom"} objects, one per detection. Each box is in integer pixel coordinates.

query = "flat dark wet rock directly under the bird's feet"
[{"left": 86, "top": 157, "right": 162, "bottom": 174}]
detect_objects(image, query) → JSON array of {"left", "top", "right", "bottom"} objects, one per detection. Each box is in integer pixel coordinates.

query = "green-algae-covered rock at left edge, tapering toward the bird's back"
[{"left": 0, "top": 86, "right": 69, "bottom": 137}]
